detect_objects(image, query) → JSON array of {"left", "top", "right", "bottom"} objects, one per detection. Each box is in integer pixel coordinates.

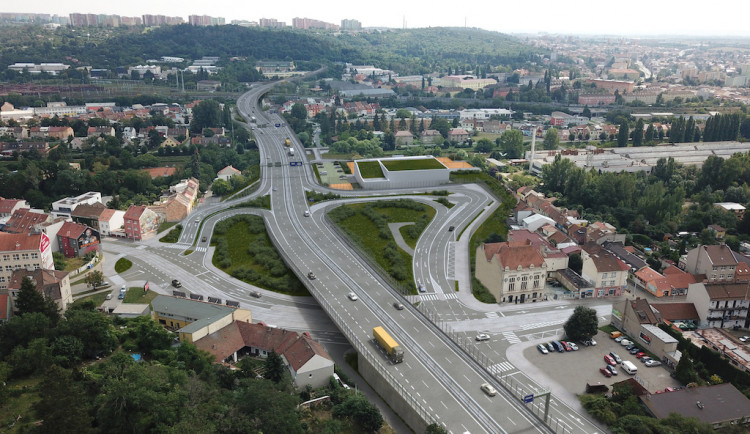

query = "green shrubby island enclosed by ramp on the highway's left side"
[{"left": 211, "top": 215, "right": 310, "bottom": 296}]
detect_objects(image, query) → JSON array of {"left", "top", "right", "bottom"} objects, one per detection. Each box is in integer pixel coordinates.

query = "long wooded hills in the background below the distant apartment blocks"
[{"left": 0, "top": 25, "right": 543, "bottom": 74}]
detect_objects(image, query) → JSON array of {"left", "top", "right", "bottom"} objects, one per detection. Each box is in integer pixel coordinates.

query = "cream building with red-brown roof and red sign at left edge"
[{"left": 0, "top": 232, "right": 55, "bottom": 289}]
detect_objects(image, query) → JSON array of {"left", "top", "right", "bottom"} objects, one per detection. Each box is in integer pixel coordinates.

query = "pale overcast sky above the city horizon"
[{"left": 8, "top": 0, "right": 750, "bottom": 37}]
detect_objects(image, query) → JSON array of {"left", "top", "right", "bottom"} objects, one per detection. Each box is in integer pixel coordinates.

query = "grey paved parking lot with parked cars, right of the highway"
[{"left": 523, "top": 331, "right": 680, "bottom": 394}]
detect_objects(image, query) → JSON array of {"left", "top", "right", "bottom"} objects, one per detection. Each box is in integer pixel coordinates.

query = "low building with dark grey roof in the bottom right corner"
[{"left": 638, "top": 383, "right": 750, "bottom": 429}]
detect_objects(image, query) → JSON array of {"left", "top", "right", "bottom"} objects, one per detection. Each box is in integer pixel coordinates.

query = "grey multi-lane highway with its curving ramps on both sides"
[{"left": 108, "top": 79, "right": 601, "bottom": 433}]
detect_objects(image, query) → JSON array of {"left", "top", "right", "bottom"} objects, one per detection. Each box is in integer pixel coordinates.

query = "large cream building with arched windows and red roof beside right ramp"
[{"left": 476, "top": 241, "right": 547, "bottom": 303}]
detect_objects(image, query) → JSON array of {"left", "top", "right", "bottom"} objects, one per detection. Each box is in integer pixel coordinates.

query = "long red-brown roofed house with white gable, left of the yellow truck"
[{"left": 194, "top": 321, "right": 334, "bottom": 388}]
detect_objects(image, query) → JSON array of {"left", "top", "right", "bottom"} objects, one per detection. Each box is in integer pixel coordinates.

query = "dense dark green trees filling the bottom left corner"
[{"left": 0, "top": 279, "right": 383, "bottom": 434}]
